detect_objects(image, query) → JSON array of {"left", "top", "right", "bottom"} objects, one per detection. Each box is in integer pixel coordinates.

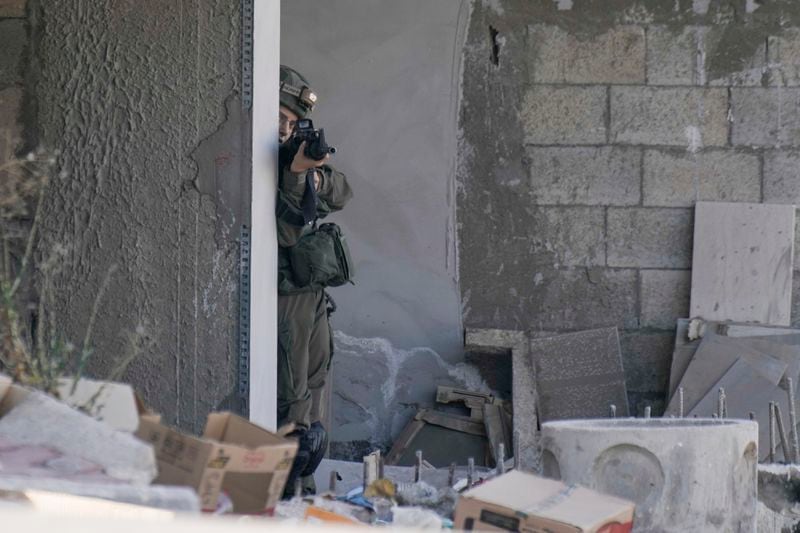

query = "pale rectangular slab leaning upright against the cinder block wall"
[{"left": 690, "top": 202, "right": 795, "bottom": 326}]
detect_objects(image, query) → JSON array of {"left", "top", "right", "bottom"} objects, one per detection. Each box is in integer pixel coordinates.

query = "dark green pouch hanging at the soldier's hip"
[{"left": 290, "top": 222, "right": 353, "bottom": 287}]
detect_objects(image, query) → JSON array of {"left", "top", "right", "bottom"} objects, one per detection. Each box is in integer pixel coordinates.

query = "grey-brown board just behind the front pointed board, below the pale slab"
[{"left": 664, "top": 333, "right": 788, "bottom": 415}]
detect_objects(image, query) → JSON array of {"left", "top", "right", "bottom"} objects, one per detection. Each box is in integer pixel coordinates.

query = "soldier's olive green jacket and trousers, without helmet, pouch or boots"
[{"left": 278, "top": 165, "right": 352, "bottom": 428}]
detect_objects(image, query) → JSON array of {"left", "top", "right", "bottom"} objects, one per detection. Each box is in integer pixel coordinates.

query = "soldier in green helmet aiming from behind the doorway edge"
[{"left": 276, "top": 65, "right": 352, "bottom": 495}]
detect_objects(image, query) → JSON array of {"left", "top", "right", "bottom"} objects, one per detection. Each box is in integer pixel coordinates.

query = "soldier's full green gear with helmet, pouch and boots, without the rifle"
[{"left": 276, "top": 65, "right": 352, "bottom": 497}]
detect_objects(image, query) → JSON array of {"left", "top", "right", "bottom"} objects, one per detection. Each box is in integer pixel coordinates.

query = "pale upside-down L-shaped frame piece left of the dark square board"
[{"left": 464, "top": 329, "right": 542, "bottom": 472}]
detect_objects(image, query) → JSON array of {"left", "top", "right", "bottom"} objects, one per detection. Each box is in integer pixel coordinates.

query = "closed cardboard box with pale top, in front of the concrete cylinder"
[{"left": 455, "top": 470, "right": 634, "bottom": 533}]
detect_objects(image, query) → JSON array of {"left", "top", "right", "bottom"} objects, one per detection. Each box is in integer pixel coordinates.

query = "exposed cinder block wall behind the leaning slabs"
[{"left": 458, "top": 0, "right": 800, "bottom": 414}]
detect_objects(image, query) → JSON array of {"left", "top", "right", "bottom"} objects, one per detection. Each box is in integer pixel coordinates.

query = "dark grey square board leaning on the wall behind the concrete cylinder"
[{"left": 532, "top": 327, "right": 628, "bottom": 422}]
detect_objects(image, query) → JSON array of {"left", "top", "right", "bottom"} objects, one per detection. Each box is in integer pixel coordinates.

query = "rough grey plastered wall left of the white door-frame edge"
[{"left": 27, "top": 0, "right": 249, "bottom": 431}]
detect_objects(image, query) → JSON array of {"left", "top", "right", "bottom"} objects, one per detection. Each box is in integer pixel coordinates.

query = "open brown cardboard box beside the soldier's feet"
[{"left": 136, "top": 413, "right": 297, "bottom": 514}]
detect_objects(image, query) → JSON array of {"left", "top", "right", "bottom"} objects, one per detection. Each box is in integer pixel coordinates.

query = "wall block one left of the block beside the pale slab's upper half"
[{"left": 528, "top": 207, "right": 606, "bottom": 266}]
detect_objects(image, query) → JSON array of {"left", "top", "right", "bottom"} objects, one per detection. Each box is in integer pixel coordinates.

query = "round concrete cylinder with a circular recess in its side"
[{"left": 542, "top": 418, "right": 758, "bottom": 532}]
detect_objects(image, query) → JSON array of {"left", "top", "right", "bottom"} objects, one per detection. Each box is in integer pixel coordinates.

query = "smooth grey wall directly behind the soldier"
[{"left": 281, "top": 0, "right": 472, "bottom": 456}]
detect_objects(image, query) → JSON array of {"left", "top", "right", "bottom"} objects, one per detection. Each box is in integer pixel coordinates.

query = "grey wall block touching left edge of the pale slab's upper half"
[{"left": 607, "top": 207, "right": 692, "bottom": 268}]
